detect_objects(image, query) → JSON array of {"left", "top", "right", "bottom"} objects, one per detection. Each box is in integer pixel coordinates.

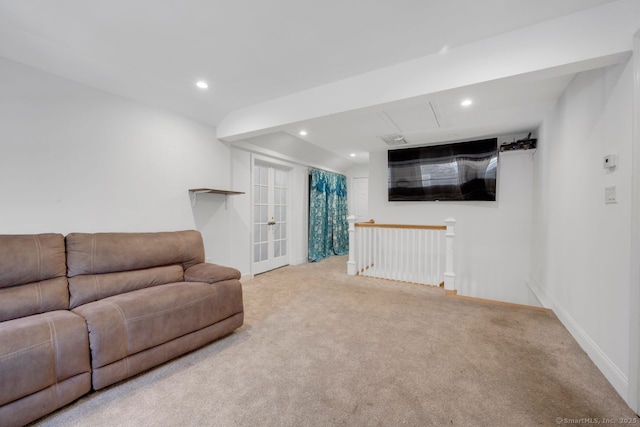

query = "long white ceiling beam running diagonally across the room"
[{"left": 217, "top": 0, "right": 640, "bottom": 141}]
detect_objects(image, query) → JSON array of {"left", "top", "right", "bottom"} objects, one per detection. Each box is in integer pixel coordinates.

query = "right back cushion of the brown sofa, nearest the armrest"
[{"left": 66, "top": 230, "right": 204, "bottom": 309}]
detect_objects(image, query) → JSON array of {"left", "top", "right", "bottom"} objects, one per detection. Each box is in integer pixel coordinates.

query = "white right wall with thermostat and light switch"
[{"left": 532, "top": 61, "right": 637, "bottom": 405}]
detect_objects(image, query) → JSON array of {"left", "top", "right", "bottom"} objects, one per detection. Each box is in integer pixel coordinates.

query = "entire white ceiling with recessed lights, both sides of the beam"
[{"left": 0, "top": 0, "right": 624, "bottom": 166}]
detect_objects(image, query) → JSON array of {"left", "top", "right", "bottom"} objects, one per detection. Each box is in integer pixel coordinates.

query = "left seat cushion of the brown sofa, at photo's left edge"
[{"left": 0, "top": 310, "right": 91, "bottom": 408}]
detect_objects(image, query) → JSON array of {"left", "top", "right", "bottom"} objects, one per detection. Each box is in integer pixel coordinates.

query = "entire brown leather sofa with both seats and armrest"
[{"left": 0, "top": 231, "right": 244, "bottom": 426}]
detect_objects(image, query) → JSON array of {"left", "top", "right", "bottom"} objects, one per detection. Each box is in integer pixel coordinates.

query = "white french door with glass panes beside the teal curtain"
[{"left": 252, "top": 161, "right": 289, "bottom": 274}]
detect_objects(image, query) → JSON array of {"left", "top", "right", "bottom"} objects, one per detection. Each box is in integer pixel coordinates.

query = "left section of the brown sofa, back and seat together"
[{"left": 0, "top": 234, "right": 91, "bottom": 426}]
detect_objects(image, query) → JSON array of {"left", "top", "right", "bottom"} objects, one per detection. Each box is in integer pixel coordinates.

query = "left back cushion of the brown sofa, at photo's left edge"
[{"left": 0, "top": 234, "right": 69, "bottom": 322}]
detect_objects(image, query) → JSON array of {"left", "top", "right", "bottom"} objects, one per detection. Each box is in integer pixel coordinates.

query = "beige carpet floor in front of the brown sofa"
[{"left": 35, "top": 257, "right": 640, "bottom": 426}]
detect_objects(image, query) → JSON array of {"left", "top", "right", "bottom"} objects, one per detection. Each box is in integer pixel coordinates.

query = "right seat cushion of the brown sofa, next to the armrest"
[{"left": 73, "top": 280, "right": 242, "bottom": 369}]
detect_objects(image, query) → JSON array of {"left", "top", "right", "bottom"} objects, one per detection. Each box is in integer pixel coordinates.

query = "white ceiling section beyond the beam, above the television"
[{"left": 280, "top": 74, "right": 573, "bottom": 162}]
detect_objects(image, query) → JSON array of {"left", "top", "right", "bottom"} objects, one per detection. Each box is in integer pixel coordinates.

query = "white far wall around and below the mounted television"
[{"left": 369, "top": 138, "right": 539, "bottom": 306}]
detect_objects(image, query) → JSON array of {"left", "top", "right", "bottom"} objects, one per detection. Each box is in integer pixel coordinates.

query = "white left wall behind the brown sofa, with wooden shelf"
[{"left": 0, "top": 59, "right": 235, "bottom": 263}]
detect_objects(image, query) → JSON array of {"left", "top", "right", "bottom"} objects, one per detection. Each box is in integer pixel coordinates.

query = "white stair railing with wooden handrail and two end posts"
[{"left": 347, "top": 216, "right": 456, "bottom": 290}]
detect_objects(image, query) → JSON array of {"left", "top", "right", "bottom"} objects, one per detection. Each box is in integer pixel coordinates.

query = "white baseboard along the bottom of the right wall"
[{"left": 527, "top": 280, "right": 629, "bottom": 401}]
